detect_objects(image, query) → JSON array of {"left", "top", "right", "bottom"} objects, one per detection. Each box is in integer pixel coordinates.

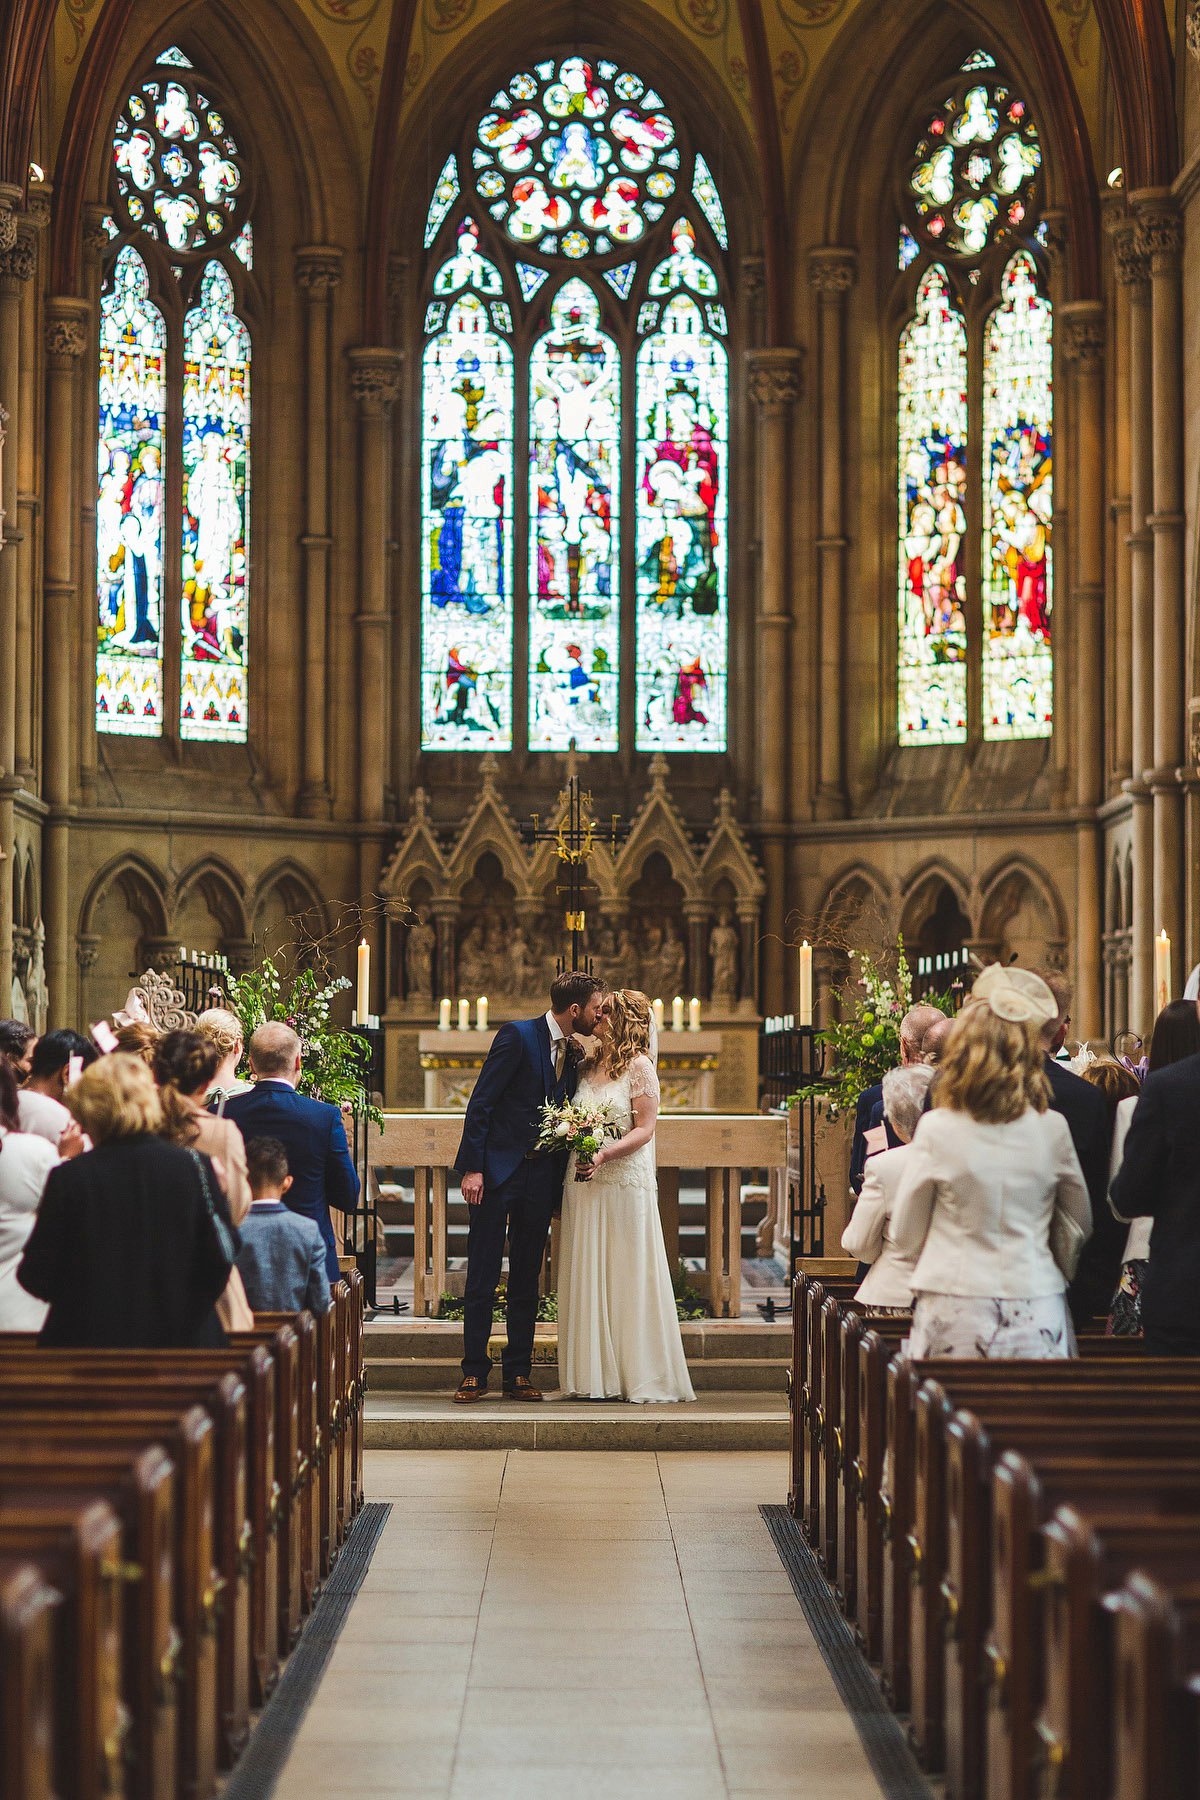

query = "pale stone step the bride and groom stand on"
[{"left": 365, "top": 1370, "right": 788, "bottom": 1451}]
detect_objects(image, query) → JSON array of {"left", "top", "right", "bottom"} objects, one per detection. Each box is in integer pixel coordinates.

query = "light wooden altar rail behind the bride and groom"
[{"left": 369, "top": 1112, "right": 788, "bottom": 1319}]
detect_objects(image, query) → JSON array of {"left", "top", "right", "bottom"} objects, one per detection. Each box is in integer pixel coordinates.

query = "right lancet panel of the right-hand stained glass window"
[{"left": 982, "top": 250, "right": 1054, "bottom": 738}]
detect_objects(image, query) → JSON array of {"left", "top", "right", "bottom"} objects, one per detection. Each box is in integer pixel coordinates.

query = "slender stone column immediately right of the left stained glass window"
[{"left": 295, "top": 243, "right": 342, "bottom": 819}]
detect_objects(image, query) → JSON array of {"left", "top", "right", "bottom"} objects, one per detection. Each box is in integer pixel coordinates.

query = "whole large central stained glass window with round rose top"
[{"left": 421, "top": 52, "right": 729, "bottom": 752}]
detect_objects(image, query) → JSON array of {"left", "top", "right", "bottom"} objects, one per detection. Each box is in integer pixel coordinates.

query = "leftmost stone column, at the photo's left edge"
[{"left": 0, "top": 223, "right": 36, "bottom": 1013}]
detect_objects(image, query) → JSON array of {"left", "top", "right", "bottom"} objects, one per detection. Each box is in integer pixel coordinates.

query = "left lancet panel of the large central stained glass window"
[{"left": 421, "top": 292, "right": 513, "bottom": 751}]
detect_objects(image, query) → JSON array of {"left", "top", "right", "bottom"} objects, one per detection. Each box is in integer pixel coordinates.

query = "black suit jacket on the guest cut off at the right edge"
[{"left": 1112, "top": 1057, "right": 1200, "bottom": 1352}]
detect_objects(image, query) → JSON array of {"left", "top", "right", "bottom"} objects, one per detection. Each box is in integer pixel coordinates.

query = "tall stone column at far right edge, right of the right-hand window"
[{"left": 1130, "top": 187, "right": 1195, "bottom": 1000}]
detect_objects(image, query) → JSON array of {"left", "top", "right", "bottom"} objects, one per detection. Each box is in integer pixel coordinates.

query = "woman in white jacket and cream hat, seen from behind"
[{"left": 891, "top": 963, "right": 1092, "bottom": 1357}]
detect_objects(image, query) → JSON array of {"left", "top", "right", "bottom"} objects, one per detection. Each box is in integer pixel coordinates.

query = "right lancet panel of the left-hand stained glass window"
[{"left": 180, "top": 263, "right": 250, "bottom": 743}]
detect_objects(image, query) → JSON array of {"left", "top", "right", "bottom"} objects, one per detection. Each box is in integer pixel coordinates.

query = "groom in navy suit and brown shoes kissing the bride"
[{"left": 453, "top": 970, "right": 606, "bottom": 1404}]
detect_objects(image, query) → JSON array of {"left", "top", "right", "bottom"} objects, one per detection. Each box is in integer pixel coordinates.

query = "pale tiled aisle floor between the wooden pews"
[{"left": 275, "top": 1451, "right": 892, "bottom": 1800}]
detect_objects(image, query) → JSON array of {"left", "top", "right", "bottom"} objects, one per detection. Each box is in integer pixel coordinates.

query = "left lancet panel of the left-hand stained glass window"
[{"left": 95, "top": 248, "right": 167, "bottom": 738}]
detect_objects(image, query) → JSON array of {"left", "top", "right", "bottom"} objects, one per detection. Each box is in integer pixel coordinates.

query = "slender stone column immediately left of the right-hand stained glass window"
[{"left": 805, "top": 248, "right": 858, "bottom": 820}]
